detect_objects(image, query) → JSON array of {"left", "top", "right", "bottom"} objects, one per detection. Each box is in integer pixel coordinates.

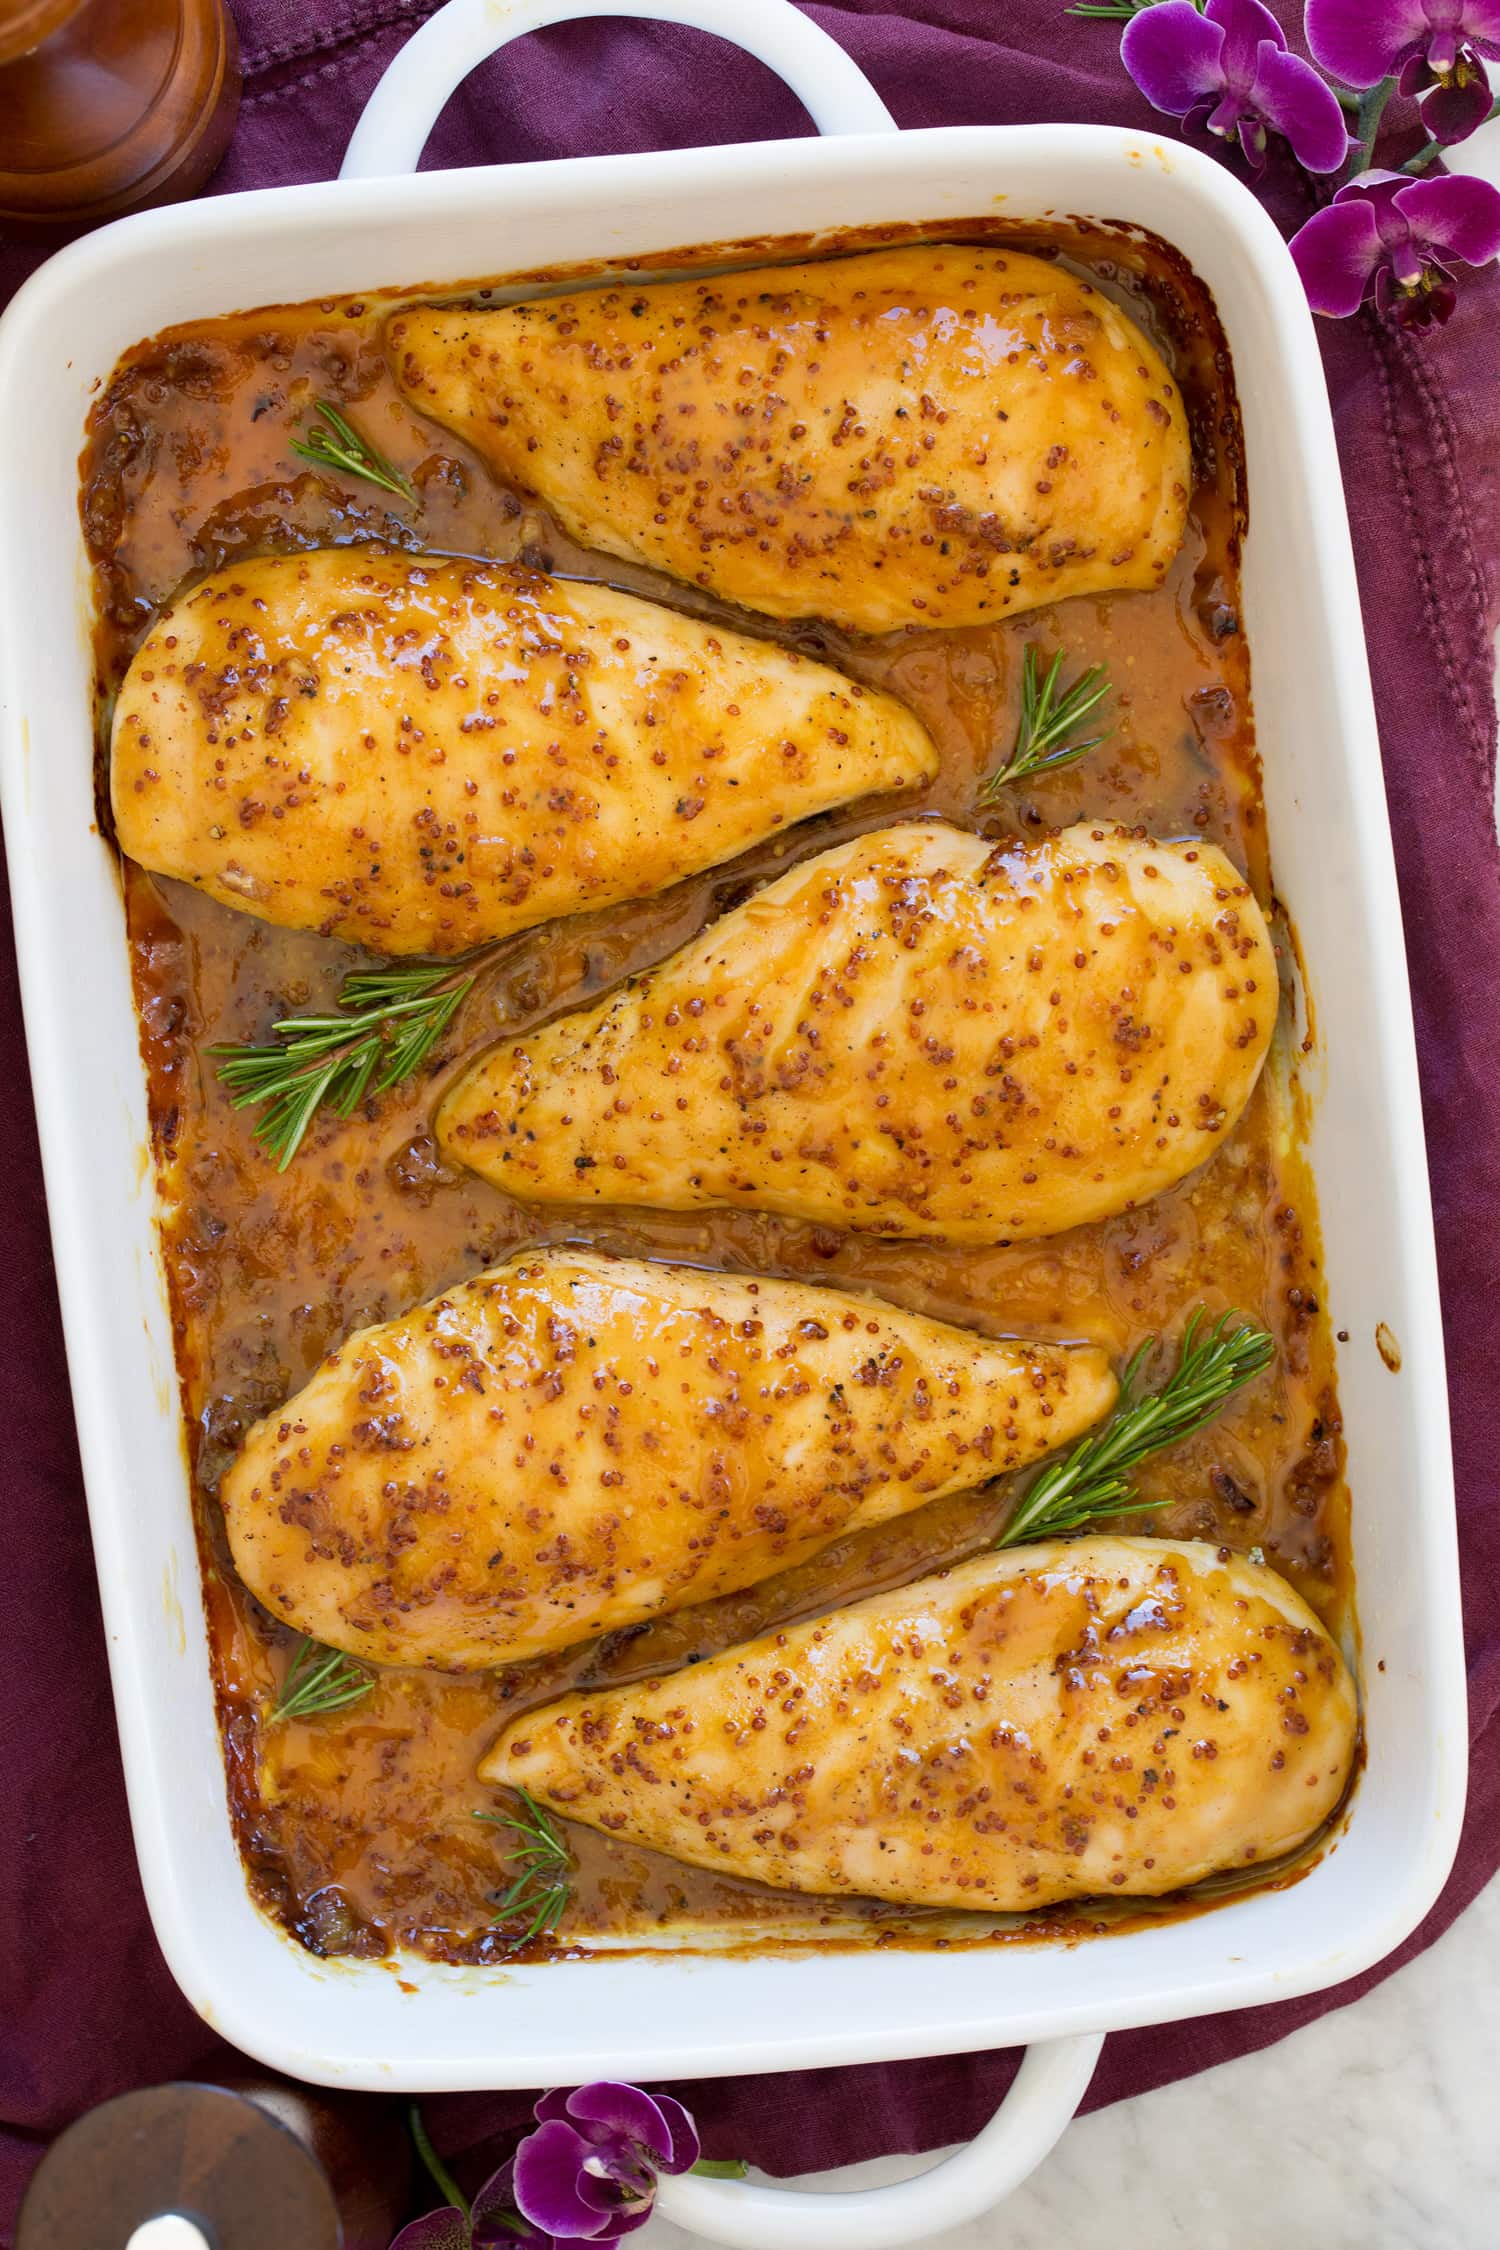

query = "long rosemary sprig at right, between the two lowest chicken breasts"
[{"left": 996, "top": 1305, "right": 1275, "bottom": 1546}]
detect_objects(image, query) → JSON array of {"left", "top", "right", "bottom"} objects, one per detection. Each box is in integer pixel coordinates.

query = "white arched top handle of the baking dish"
[{"left": 340, "top": 0, "right": 895, "bottom": 180}]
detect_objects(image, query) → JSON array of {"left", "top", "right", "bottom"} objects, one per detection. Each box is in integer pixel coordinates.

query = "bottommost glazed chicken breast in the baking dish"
[{"left": 492, "top": 1537, "right": 1358, "bottom": 1913}]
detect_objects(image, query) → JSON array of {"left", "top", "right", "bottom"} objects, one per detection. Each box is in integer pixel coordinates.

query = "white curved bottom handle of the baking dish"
[{"left": 657, "top": 2032, "right": 1104, "bottom": 2250}]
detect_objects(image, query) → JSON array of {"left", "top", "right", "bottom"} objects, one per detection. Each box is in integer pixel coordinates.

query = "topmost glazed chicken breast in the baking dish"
[{"left": 387, "top": 243, "right": 1192, "bottom": 632}]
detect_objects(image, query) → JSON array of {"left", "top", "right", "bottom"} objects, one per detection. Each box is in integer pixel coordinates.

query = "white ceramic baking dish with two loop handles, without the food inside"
[{"left": 0, "top": 0, "right": 1466, "bottom": 2250}]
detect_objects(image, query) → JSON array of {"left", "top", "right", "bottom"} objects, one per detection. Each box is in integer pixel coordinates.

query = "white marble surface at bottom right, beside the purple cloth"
[{"left": 647, "top": 1879, "right": 1500, "bottom": 2250}]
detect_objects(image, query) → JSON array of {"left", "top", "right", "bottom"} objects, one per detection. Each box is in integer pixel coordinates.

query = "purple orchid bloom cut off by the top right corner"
[{"left": 1307, "top": 0, "right": 1500, "bottom": 146}]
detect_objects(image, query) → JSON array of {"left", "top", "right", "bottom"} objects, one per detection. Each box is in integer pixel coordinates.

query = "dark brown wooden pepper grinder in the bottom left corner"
[{"left": 16, "top": 2077, "right": 412, "bottom": 2250}]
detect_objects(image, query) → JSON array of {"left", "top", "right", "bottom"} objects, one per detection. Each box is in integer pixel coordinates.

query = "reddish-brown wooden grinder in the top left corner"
[{"left": 0, "top": 0, "right": 241, "bottom": 239}]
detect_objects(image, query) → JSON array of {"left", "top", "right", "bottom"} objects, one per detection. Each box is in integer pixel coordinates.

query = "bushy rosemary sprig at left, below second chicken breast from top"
[{"left": 209, "top": 961, "right": 475, "bottom": 1172}]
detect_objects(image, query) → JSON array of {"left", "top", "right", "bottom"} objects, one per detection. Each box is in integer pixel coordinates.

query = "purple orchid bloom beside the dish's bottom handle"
[{"left": 515, "top": 2079, "right": 699, "bottom": 2250}]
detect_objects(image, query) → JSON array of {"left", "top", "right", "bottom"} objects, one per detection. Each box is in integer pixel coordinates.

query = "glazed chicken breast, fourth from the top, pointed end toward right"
[{"left": 220, "top": 1249, "right": 1115, "bottom": 1670}]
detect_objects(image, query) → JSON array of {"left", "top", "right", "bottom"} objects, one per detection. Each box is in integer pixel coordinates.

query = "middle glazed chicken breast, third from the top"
[{"left": 436, "top": 821, "right": 1277, "bottom": 1242}]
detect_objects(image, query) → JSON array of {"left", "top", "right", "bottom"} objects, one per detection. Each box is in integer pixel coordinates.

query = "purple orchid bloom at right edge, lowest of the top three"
[{"left": 1291, "top": 171, "right": 1500, "bottom": 329}]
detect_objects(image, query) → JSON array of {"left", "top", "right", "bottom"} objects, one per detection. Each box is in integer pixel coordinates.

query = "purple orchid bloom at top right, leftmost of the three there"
[{"left": 1120, "top": 0, "right": 1349, "bottom": 173}]
